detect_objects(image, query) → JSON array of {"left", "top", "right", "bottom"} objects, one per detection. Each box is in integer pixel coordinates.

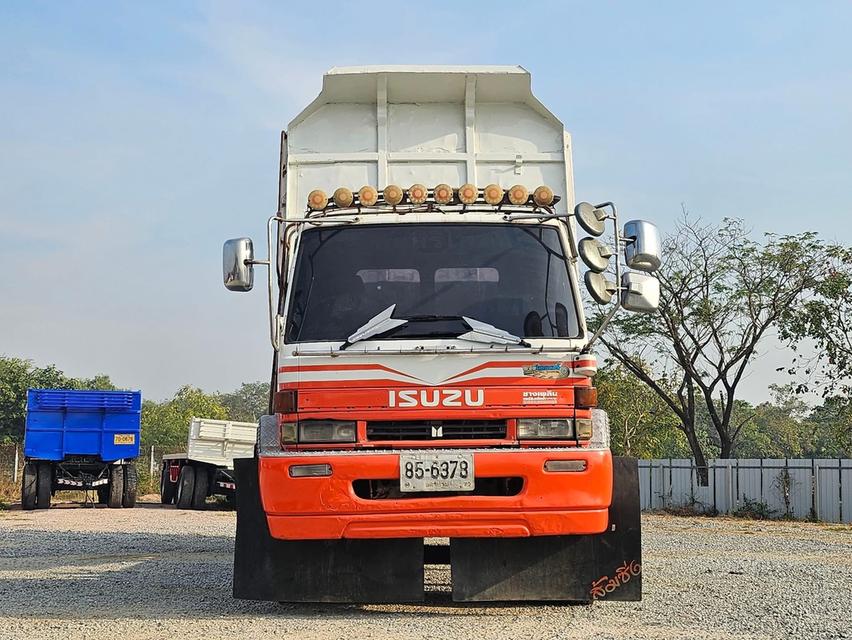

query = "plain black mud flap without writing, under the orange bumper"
[{"left": 234, "top": 458, "right": 424, "bottom": 603}]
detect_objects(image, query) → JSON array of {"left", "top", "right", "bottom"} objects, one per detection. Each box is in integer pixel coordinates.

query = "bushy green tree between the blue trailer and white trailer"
[{"left": 142, "top": 385, "right": 228, "bottom": 449}]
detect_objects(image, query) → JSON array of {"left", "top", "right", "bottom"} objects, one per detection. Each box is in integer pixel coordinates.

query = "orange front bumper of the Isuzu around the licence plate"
[{"left": 259, "top": 449, "right": 612, "bottom": 540}]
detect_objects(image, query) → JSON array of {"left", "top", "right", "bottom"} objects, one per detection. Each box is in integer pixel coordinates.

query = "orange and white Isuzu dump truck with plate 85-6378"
[{"left": 223, "top": 66, "right": 660, "bottom": 602}]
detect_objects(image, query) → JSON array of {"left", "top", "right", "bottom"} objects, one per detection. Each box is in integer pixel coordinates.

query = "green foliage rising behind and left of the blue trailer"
[{"left": 0, "top": 356, "right": 116, "bottom": 444}]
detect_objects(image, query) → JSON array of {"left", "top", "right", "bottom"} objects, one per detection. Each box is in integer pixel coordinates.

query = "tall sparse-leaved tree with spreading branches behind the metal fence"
[{"left": 601, "top": 214, "right": 844, "bottom": 482}]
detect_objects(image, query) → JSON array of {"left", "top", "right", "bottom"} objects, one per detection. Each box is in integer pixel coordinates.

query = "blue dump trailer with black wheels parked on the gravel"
[{"left": 21, "top": 389, "right": 142, "bottom": 509}]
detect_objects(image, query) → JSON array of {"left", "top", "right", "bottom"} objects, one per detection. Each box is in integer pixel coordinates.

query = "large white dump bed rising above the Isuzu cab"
[{"left": 280, "top": 66, "right": 574, "bottom": 218}]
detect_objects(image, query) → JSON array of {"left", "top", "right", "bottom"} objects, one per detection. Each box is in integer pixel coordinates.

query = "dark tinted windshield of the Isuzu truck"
[{"left": 285, "top": 223, "right": 580, "bottom": 342}]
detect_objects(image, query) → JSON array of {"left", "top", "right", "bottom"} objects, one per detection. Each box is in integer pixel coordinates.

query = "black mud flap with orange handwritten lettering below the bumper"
[{"left": 450, "top": 457, "right": 642, "bottom": 602}]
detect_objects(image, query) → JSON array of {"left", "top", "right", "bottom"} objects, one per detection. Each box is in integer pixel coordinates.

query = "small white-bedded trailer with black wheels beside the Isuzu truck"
[{"left": 160, "top": 418, "right": 257, "bottom": 509}]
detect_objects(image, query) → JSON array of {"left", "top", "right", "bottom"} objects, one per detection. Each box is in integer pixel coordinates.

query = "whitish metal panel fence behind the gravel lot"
[{"left": 639, "top": 458, "right": 852, "bottom": 523}]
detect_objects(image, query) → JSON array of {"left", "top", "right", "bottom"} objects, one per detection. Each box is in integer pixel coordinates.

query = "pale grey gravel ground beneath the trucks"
[{"left": 0, "top": 504, "right": 852, "bottom": 640}]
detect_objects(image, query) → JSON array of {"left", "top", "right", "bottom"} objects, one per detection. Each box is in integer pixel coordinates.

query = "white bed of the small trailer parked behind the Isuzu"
[{"left": 186, "top": 418, "right": 257, "bottom": 467}]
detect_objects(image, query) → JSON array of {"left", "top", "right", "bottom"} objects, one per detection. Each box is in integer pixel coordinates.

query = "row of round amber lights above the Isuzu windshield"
[{"left": 308, "top": 184, "right": 555, "bottom": 211}]
